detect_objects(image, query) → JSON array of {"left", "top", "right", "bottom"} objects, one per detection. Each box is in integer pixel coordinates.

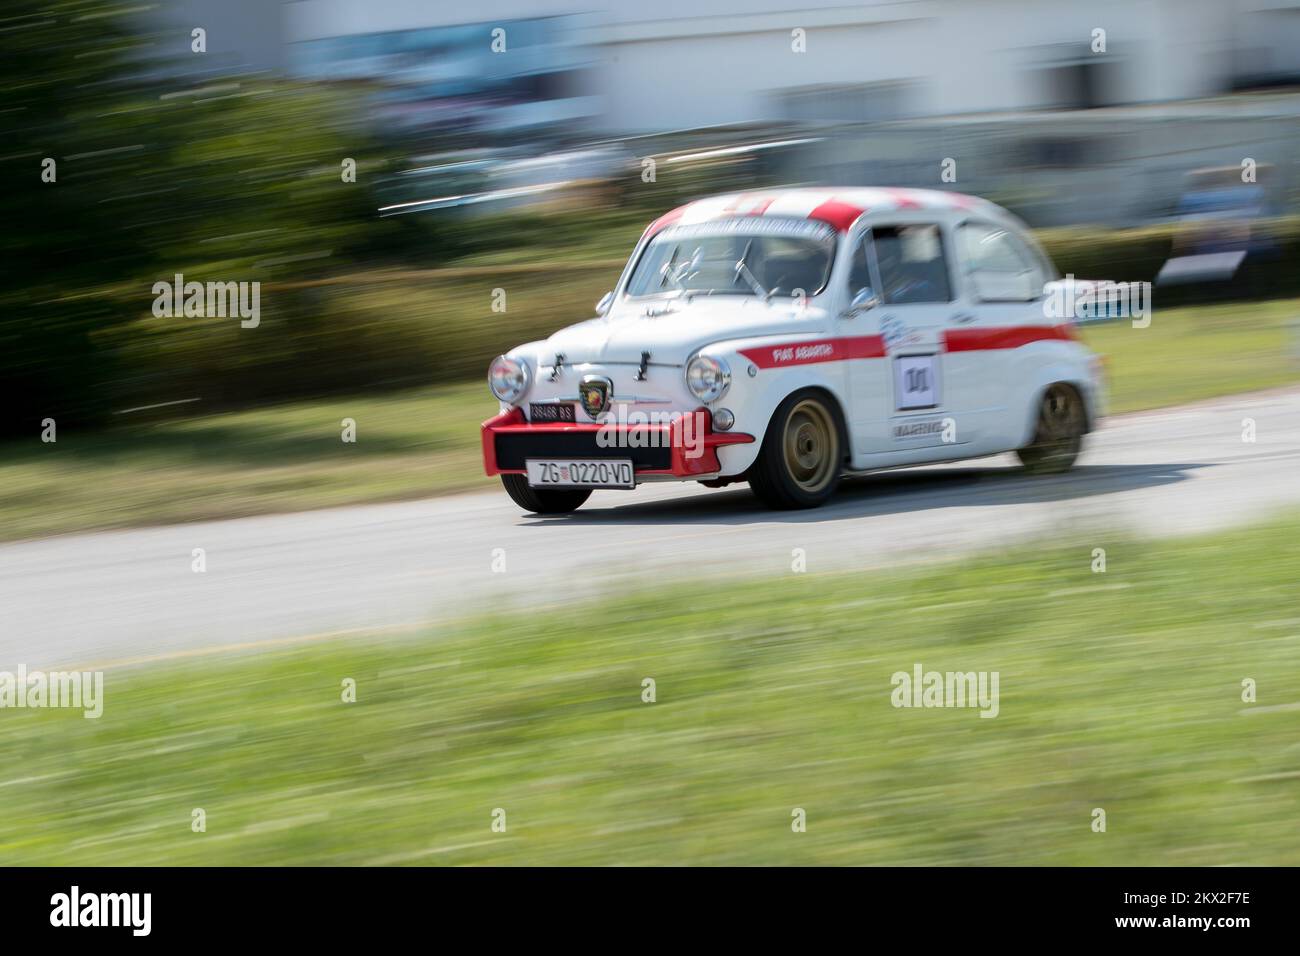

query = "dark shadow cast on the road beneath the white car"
[{"left": 521, "top": 462, "right": 1213, "bottom": 525}]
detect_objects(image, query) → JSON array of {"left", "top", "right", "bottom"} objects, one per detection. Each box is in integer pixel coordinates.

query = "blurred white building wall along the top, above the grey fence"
[{"left": 283, "top": 0, "right": 1300, "bottom": 133}]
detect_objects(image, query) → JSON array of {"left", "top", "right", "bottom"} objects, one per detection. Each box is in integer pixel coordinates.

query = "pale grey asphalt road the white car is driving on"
[{"left": 0, "top": 392, "right": 1300, "bottom": 670}]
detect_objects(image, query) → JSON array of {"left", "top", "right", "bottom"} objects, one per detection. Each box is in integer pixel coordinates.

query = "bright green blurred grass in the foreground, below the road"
[{"left": 0, "top": 518, "right": 1300, "bottom": 865}]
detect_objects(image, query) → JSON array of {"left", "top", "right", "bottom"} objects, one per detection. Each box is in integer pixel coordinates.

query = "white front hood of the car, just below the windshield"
[{"left": 537, "top": 295, "right": 820, "bottom": 365}]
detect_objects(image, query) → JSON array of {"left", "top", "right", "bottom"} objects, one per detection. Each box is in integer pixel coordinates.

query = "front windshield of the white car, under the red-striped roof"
[{"left": 627, "top": 216, "right": 836, "bottom": 297}]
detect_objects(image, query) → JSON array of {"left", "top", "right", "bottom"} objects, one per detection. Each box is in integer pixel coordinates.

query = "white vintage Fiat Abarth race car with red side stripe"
[{"left": 482, "top": 189, "right": 1102, "bottom": 514}]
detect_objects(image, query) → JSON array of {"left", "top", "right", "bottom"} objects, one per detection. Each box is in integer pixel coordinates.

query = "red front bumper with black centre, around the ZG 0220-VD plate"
[{"left": 482, "top": 407, "right": 754, "bottom": 479}]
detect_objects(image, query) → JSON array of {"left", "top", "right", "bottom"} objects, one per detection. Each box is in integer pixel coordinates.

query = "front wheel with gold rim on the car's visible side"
[{"left": 749, "top": 389, "right": 844, "bottom": 510}]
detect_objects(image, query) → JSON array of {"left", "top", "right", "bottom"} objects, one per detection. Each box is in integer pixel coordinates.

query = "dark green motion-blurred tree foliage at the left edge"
[{"left": 0, "top": 0, "right": 400, "bottom": 436}]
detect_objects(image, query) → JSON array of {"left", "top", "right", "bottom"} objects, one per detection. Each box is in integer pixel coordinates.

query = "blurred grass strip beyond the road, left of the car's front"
[{"left": 0, "top": 382, "right": 498, "bottom": 538}]
